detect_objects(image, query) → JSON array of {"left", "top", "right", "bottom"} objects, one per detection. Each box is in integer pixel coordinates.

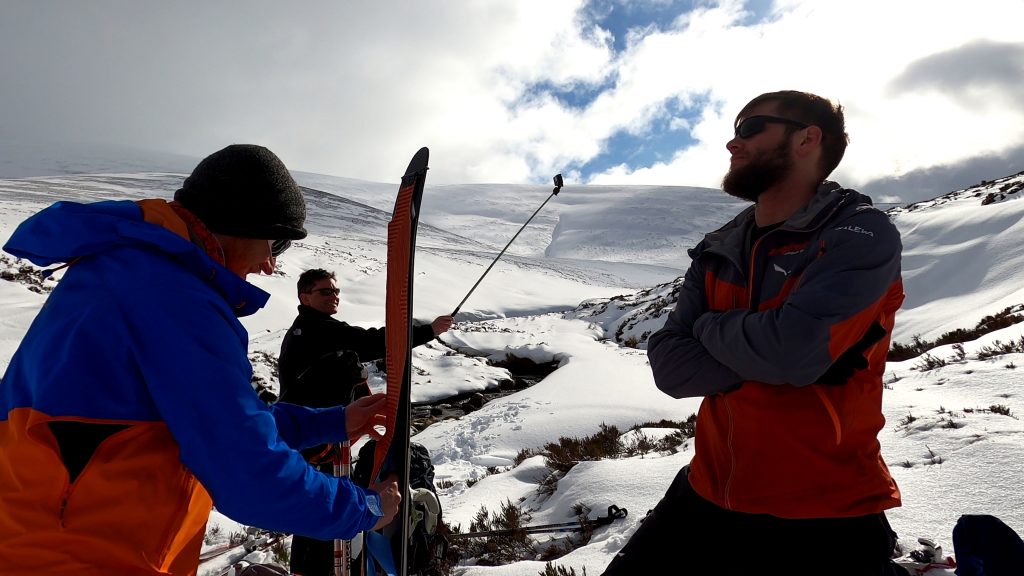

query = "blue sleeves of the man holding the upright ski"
[{"left": 123, "top": 288, "right": 383, "bottom": 539}]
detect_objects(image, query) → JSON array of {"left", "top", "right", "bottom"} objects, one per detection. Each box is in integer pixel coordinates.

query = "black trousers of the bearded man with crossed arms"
[{"left": 603, "top": 467, "right": 896, "bottom": 576}]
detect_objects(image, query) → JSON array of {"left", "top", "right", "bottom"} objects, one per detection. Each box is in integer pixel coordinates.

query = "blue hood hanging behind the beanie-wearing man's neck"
[{"left": 3, "top": 200, "right": 270, "bottom": 317}]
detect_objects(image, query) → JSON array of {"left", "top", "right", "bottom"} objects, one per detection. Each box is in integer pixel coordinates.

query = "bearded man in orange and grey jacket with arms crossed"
[{"left": 604, "top": 91, "right": 903, "bottom": 576}]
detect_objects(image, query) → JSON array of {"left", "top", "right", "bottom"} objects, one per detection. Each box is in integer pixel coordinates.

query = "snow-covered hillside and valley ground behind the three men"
[{"left": 0, "top": 166, "right": 1024, "bottom": 576}]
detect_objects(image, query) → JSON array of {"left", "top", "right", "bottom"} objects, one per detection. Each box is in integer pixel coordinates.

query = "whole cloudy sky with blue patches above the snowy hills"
[{"left": 0, "top": 0, "right": 1024, "bottom": 201}]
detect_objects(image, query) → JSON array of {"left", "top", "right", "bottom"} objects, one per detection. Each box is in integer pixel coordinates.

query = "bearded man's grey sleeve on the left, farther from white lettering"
[{"left": 647, "top": 254, "right": 742, "bottom": 398}]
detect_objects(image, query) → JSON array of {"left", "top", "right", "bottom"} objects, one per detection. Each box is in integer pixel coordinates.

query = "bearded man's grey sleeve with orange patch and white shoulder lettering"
[{"left": 693, "top": 209, "right": 902, "bottom": 386}]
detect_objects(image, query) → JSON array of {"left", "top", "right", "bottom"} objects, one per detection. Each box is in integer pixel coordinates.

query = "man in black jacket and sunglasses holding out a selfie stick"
[{"left": 279, "top": 269, "right": 453, "bottom": 576}]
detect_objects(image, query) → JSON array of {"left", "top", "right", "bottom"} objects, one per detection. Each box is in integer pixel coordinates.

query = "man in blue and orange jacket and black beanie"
[{"left": 0, "top": 145, "right": 400, "bottom": 575}]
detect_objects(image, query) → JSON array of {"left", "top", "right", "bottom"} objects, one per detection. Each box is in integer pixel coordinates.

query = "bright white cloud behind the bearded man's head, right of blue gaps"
[{"left": 592, "top": 1, "right": 1024, "bottom": 194}]
